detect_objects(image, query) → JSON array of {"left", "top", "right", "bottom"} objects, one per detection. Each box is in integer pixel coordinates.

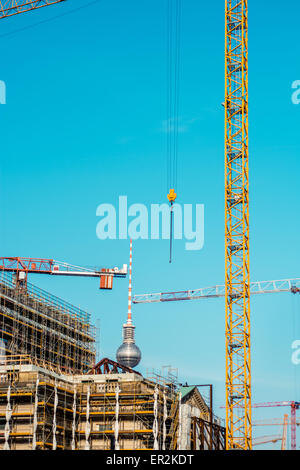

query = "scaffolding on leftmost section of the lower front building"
[{"left": 0, "top": 360, "right": 74, "bottom": 450}]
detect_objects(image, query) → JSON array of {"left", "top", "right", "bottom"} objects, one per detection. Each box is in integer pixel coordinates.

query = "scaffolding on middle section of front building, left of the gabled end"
[{"left": 78, "top": 373, "right": 176, "bottom": 450}]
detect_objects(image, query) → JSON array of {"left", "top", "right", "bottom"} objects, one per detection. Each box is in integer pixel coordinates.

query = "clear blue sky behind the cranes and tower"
[{"left": 0, "top": 0, "right": 300, "bottom": 446}]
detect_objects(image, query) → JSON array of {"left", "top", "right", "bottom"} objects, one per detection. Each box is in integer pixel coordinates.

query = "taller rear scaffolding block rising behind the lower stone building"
[{"left": 0, "top": 272, "right": 96, "bottom": 373}]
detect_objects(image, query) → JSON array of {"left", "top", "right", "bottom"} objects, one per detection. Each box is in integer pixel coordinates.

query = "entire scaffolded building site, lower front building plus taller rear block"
[{"left": 0, "top": 272, "right": 225, "bottom": 450}]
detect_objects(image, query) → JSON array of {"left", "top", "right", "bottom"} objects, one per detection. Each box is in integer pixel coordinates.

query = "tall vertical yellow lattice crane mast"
[{"left": 224, "top": 0, "right": 252, "bottom": 450}]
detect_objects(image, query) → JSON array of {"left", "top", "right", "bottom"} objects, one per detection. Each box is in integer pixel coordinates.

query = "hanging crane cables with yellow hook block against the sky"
[{"left": 166, "top": 0, "right": 182, "bottom": 263}]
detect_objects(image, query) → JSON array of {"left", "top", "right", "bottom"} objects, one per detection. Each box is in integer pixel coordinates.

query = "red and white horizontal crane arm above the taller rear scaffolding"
[{"left": 0, "top": 257, "right": 127, "bottom": 289}]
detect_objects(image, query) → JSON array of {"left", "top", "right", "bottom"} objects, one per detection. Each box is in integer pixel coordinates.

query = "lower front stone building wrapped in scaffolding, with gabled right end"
[{"left": 0, "top": 356, "right": 225, "bottom": 450}]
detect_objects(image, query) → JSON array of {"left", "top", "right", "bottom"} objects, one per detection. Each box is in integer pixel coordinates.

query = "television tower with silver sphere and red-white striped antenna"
[{"left": 116, "top": 240, "right": 142, "bottom": 368}]
